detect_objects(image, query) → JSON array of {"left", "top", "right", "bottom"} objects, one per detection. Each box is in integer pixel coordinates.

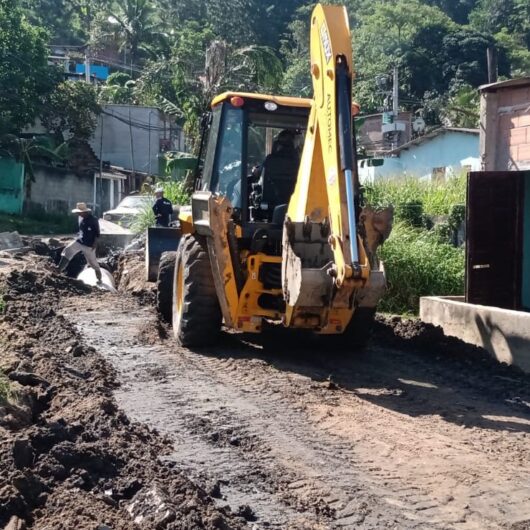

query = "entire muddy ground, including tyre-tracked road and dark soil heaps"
[{"left": 0, "top": 254, "right": 530, "bottom": 530}]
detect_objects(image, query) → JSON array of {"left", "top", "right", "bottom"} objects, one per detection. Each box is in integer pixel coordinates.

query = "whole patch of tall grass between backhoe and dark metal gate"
[{"left": 364, "top": 174, "right": 466, "bottom": 314}]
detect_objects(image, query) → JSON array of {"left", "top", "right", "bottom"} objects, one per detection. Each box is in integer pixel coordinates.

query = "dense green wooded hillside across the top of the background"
[{"left": 0, "top": 0, "right": 530, "bottom": 144}]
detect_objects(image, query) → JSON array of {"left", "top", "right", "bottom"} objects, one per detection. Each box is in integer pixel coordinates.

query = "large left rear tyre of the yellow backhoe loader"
[{"left": 173, "top": 234, "right": 222, "bottom": 347}]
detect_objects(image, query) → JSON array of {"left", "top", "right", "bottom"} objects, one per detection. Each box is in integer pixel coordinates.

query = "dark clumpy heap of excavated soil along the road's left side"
[{"left": 0, "top": 270, "right": 244, "bottom": 530}]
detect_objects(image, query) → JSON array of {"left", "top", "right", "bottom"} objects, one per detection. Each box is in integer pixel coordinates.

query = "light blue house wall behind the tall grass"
[{"left": 359, "top": 131, "right": 480, "bottom": 182}]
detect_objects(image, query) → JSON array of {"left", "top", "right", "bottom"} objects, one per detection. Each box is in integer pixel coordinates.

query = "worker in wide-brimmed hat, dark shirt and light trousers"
[{"left": 59, "top": 202, "right": 101, "bottom": 284}]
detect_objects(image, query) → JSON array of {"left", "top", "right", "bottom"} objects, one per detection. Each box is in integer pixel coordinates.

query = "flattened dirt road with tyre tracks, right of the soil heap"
[{"left": 65, "top": 295, "right": 530, "bottom": 530}]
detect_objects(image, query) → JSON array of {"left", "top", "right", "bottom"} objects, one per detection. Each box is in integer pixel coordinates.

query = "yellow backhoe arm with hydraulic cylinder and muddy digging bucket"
[{"left": 282, "top": 4, "right": 370, "bottom": 332}]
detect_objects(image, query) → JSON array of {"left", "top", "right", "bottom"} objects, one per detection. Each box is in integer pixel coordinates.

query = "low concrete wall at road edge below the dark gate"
[{"left": 420, "top": 296, "right": 530, "bottom": 372}]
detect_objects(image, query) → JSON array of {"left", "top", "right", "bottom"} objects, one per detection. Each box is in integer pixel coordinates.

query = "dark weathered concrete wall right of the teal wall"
[{"left": 26, "top": 166, "right": 94, "bottom": 213}]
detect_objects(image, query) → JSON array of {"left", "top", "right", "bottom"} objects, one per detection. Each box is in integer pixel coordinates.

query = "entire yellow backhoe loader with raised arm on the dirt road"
[{"left": 155, "top": 4, "right": 392, "bottom": 346}]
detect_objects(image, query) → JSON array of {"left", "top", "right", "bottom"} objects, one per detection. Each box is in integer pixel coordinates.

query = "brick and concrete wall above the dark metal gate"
[{"left": 480, "top": 80, "right": 530, "bottom": 171}]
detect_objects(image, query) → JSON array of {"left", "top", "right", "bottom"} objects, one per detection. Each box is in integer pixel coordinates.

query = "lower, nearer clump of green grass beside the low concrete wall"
[{"left": 379, "top": 223, "right": 464, "bottom": 314}]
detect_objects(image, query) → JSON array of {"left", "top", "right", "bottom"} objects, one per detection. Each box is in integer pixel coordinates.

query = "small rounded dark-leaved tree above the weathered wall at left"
[{"left": 41, "top": 81, "right": 101, "bottom": 142}]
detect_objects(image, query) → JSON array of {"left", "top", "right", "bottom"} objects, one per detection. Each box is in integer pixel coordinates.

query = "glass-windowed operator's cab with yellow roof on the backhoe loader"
[{"left": 196, "top": 93, "right": 311, "bottom": 227}]
